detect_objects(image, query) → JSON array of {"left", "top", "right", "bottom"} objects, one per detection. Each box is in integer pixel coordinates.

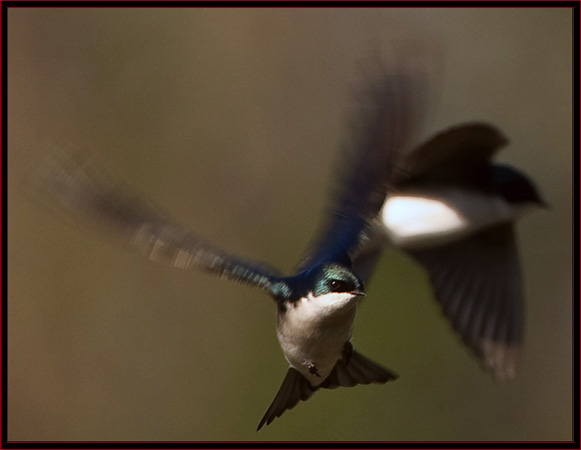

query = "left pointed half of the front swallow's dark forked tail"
[{"left": 256, "top": 367, "right": 318, "bottom": 431}]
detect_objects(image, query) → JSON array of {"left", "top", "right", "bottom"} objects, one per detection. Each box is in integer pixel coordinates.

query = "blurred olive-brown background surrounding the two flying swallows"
[{"left": 8, "top": 8, "right": 572, "bottom": 441}]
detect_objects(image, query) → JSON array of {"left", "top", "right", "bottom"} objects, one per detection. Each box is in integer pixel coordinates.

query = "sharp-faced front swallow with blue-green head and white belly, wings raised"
[{"left": 31, "top": 64, "right": 409, "bottom": 429}]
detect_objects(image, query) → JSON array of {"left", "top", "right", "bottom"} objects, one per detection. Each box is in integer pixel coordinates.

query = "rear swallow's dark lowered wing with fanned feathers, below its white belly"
[{"left": 409, "top": 224, "right": 524, "bottom": 379}]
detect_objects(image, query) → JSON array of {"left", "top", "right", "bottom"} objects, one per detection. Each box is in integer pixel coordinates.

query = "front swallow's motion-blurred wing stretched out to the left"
[{"left": 31, "top": 157, "right": 278, "bottom": 290}]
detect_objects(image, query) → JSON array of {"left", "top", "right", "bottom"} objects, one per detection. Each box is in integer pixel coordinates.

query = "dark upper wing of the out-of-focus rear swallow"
[{"left": 393, "top": 123, "right": 508, "bottom": 185}]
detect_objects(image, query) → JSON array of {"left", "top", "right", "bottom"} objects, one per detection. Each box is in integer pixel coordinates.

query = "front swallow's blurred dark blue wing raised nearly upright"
[{"left": 298, "top": 61, "right": 421, "bottom": 270}]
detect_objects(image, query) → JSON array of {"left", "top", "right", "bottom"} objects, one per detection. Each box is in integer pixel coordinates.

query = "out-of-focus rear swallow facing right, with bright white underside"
[{"left": 355, "top": 123, "right": 545, "bottom": 380}]
